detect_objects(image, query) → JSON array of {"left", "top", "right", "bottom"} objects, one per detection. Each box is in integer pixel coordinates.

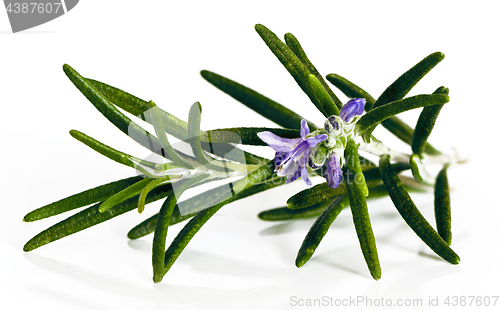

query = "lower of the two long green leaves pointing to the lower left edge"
[{"left": 23, "top": 184, "right": 172, "bottom": 252}]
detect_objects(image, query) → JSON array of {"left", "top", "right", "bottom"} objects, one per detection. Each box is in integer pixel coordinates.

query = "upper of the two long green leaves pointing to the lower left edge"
[{"left": 23, "top": 176, "right": 143, "bottom": 222}]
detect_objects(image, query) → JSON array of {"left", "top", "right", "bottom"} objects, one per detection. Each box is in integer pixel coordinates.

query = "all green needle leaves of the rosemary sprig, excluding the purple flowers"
[{"left": 24, "top": 25, "right": 459, "bottom": 282}]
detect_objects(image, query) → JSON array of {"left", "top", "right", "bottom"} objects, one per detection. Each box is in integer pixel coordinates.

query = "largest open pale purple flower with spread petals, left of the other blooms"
[{"left": 257, "top": 120, "right": 328, "bottom": 186}]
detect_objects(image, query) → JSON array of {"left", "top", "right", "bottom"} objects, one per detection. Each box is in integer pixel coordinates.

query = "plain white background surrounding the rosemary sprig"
[{"left": 0, "top": 0, "right": 500, "bottom": 310}]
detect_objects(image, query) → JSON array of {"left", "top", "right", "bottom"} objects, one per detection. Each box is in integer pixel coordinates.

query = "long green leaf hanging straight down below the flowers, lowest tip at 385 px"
[{"left": 345, "top": 140, "right": 382, "bottom": 280}]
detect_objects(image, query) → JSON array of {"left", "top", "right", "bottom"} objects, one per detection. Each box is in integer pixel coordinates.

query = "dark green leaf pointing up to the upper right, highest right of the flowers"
[{"left": 371, "top": 52, "right": 444, "bottom": 109}]
